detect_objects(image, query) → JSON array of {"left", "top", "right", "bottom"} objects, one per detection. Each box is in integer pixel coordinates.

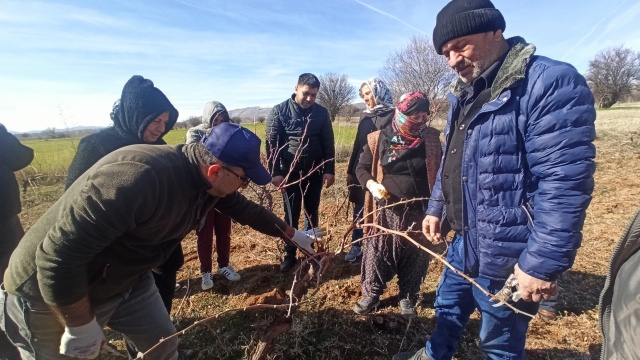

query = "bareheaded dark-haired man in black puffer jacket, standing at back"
[{"left": 265, "top": 73, "right": 335, "bottom": 272}]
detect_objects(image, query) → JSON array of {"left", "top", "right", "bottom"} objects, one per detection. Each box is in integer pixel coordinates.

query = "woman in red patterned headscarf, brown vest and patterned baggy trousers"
[{"left": 353, "top": 92, "right": 442, "bottom": 317}]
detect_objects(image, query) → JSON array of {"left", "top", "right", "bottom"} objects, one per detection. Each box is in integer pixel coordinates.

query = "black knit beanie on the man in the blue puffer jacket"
[{"left": 433, "top": 0, "right": 506, "bottom": 55}]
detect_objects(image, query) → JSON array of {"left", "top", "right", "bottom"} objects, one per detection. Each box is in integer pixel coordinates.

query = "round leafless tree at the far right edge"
[{"left": 586, "top": 45, "right": 640, "bottom": 108}]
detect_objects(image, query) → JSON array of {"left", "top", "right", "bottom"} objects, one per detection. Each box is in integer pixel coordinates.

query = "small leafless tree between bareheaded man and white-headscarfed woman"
[{"left": 317, "top": 72, "right": 356, "bottom": 122}]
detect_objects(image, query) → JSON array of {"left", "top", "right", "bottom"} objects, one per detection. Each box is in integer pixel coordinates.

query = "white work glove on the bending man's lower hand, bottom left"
[{"left": 60, "top": 317, "right": 106, "bottom": 359}]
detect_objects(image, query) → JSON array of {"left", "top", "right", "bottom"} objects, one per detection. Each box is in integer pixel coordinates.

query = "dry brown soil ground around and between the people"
[{"left": 13, "top": 107, "right": 640, "bottom": 360}]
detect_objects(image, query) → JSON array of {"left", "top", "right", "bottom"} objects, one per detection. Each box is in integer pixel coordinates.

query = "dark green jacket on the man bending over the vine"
[{"left": 4, "top": 144, "right": 286, "bottom": 306}]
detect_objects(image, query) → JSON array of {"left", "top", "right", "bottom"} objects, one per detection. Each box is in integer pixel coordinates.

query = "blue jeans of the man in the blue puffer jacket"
[{"left": 426, "top": 234, "right": 538, "bottom": 360}]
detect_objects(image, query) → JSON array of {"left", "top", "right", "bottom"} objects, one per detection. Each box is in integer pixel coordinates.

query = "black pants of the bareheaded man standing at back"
[{"left": 283, "top": 171, "right": 322, "bottom": 256}]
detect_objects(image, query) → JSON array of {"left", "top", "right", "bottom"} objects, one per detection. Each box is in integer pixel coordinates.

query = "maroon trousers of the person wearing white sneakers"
[{"left": 197, "top": 209, "right": 231, "bottom": 273}]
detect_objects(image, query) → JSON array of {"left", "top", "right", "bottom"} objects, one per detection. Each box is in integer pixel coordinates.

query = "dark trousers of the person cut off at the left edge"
[{"left": 0, "top": 215, "right": 24, "bottom": 360}]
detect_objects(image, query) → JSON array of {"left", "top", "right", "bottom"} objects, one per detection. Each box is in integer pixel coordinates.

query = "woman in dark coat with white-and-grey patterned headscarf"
[{"left": 344, "top": 78, "right": 395, "bottom": 261}]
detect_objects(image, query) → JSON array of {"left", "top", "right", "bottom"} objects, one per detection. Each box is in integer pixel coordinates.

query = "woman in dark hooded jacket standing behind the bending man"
[{"left": 65, "top": 75, "right": 184, "bottom": 313}]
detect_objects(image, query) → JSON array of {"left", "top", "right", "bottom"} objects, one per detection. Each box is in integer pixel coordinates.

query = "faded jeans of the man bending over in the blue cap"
[{"left": 0, "top": 274, "right": 178, "bottom": 360}]
